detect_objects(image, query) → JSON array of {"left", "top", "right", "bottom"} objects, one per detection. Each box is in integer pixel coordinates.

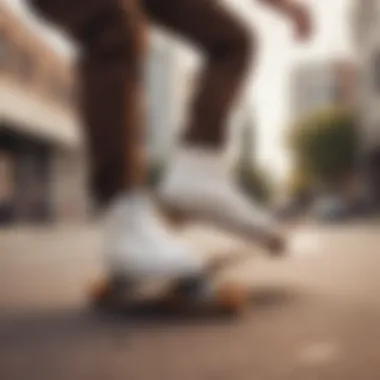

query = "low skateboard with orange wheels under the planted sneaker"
[{"left": 88, "top": 253, "right": 250, "bottom": 315}]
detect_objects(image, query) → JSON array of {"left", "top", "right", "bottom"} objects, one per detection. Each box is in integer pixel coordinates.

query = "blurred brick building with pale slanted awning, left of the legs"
[{"left": 0, "top": 6, "right": 86, "bottom": 223}]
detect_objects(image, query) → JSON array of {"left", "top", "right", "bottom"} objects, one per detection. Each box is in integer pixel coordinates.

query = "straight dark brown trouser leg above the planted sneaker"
[{"left": 31, "top": 0, "right": 145, "bottom": 205}]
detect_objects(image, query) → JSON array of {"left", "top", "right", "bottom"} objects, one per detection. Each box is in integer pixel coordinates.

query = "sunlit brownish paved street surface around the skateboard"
[{"left": 0, "top": 225, "right": 380, "bottom": 380}]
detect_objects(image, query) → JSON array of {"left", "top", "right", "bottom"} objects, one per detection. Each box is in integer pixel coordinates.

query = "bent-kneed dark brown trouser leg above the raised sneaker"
[{"left": 142, "top": 0, "right": 254, "bottom": 148}]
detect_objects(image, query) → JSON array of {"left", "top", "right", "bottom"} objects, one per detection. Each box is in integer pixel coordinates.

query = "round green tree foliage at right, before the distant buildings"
[{"left": 289, "top": 109, "right": 359, "bottom": 184}]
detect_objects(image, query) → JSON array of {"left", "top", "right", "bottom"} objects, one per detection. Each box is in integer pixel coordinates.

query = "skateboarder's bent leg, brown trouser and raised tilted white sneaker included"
[{"left": 143, "top": 0, "right": 282, "bottom": 254}]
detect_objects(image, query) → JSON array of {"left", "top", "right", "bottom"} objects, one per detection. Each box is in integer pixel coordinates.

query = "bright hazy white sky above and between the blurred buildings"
[{"left": 1, "top": 0, "right": 354, "bottom": 178}]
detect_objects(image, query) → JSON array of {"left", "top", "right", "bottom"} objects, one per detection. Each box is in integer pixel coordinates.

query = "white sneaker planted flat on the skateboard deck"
[{"left": 104, "top": 193, "right": 203, "bottom": 281}]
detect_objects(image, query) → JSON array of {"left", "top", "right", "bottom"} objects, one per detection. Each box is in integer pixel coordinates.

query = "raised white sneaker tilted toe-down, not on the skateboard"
[{"left": 159, "top": 149, "right": 284, "bottom": 252}]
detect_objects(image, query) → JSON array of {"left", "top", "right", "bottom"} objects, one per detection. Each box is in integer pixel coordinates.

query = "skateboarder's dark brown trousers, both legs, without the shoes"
[{"left": 30, "top": 0, "right": 252, "bottom": 203}]
